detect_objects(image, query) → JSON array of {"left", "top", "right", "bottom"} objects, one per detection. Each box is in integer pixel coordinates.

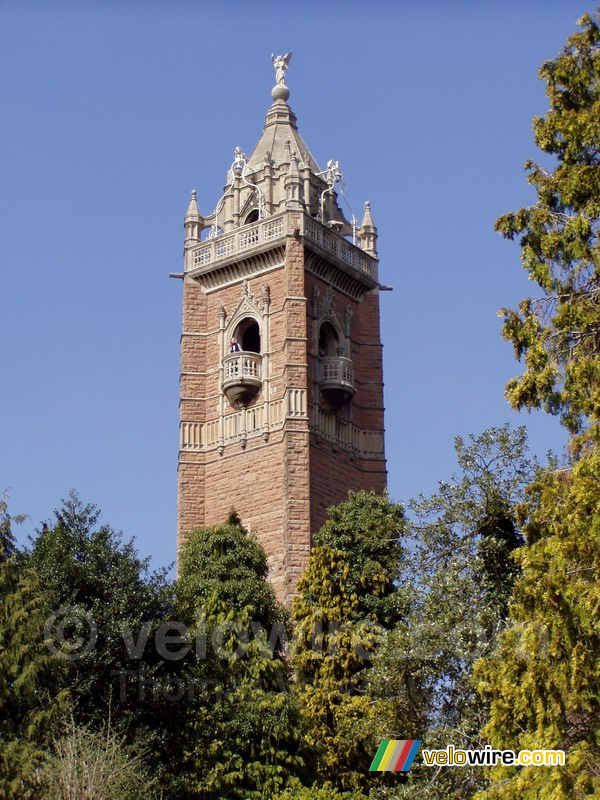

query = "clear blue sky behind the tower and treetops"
[{"left": 0, "top": 0, "right": 580, "bottom": 566}]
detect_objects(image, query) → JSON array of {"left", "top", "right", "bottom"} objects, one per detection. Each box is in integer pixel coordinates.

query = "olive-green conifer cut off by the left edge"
[{"left": 0, "top": 500, "right": 68, "bottom": 800}]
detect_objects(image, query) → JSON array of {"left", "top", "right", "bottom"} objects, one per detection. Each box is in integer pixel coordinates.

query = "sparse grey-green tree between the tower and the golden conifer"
[{"left": 371, "top": 425, "right": 531, "bottom": 800}]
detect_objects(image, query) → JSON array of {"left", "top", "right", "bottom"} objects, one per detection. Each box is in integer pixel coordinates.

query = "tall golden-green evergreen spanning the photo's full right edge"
[{"left": 476, "top": 14, "right": 600, "bottom": 800}]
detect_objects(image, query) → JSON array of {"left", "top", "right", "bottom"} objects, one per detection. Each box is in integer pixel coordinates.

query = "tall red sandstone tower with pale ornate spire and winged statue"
[{"left": 178, "top": 54, "right": 386, "bottom": 600}]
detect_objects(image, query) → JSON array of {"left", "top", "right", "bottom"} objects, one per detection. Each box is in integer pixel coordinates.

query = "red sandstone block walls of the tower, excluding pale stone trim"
[{"left": 178, "top": 228, "right": 386, "bottom": 600}]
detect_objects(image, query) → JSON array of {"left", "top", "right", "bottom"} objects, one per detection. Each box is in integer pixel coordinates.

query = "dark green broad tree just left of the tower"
[{"left": 27, "top": 493, "right": 176, "bottom": 792}]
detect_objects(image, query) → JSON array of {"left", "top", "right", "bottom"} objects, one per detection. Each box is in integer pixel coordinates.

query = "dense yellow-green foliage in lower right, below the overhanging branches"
[{"left": 476, "top": 451, "right": 600, "bottom": 800}]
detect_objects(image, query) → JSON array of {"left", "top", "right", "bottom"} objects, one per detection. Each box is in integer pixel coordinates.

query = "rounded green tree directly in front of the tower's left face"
[{"left": 177, "top": 517, "right": 302, "bottom": 800}]
